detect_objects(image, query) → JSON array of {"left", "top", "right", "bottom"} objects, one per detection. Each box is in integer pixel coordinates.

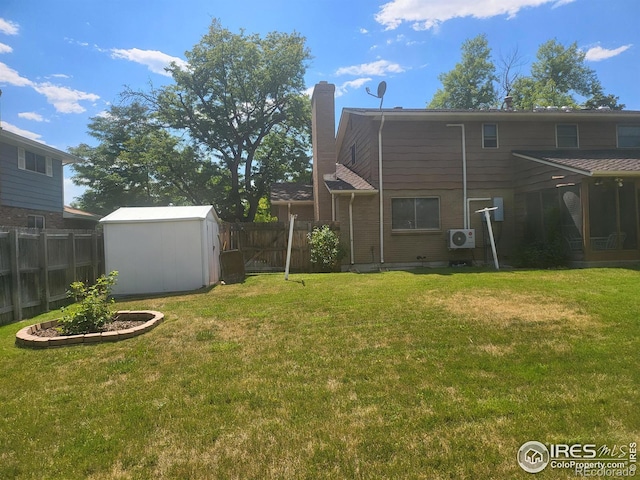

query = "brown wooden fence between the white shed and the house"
[{"left": 220, "top": 222, "right": 340, "bottom": 273}]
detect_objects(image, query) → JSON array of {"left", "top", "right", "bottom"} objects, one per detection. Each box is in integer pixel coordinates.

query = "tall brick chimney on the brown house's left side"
[{"left": 311, "top": 81, "right": 337, "bottom": 222}]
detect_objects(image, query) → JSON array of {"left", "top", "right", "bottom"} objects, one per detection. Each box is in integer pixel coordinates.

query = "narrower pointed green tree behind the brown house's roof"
[{"left": 427, "top": 35, "right": 498, "bottom": 109}]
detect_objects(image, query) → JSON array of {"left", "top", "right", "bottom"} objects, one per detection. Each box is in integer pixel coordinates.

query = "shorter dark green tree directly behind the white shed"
[{"left": 70, "top": 103, "right": 218, "bottom": 214}]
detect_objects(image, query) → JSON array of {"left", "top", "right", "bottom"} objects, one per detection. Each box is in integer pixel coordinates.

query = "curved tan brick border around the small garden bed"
[{"left": 16, "top": 310, "right": 164, "bottom": 348}]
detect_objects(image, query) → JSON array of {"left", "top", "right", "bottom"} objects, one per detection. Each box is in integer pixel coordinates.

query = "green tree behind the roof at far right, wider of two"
[{"left": 511, "top": 40, "right": 624, "bottom": 110}]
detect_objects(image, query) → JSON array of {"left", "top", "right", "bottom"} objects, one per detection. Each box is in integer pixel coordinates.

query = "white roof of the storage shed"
[{"left": 100, "top": 205, "right": 218, "bottom": 223}]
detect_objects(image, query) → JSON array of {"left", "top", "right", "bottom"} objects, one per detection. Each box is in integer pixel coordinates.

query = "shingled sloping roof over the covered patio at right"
[{"left": 512, "top": 149, "right": 640, "bottom": 177}]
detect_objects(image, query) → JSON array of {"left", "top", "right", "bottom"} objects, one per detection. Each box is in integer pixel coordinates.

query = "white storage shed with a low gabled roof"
[{"left": 100, "top": 205, "right": 220, "bottom": 295}]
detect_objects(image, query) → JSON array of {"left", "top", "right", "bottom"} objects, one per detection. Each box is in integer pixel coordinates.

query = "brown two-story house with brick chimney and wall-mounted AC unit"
[{"left": 312, "top": 82, "right": 640, "bottom": 267}]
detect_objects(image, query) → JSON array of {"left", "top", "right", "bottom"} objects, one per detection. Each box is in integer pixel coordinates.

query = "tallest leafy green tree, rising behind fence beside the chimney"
[{"left": 134, "top": 20, "right": 311, "bottom": 221}]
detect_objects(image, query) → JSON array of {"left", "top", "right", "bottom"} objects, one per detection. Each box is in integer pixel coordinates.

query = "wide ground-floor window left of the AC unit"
[{"left": 391, "top": 197, "right": 440, "bottom": 230}]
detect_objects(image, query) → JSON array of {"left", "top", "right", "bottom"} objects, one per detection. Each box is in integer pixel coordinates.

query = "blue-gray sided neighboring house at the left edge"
[{"left": 0, "top": 128, "right": 84, "bottom": 228}]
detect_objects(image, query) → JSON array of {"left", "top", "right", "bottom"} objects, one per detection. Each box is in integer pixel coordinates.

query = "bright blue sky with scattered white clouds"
[{"left": 0, "top": 0, "right": 640, "bottom": 203}]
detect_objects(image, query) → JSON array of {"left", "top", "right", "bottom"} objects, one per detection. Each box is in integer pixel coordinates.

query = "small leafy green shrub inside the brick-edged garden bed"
[{"left": 59, "top": 271, "right": 118, "bottom": 335}]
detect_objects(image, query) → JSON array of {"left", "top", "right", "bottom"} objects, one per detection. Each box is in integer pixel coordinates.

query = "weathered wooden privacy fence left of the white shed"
[{"left": 0, "top": 227, "right": 104, "bottom": 324}]
